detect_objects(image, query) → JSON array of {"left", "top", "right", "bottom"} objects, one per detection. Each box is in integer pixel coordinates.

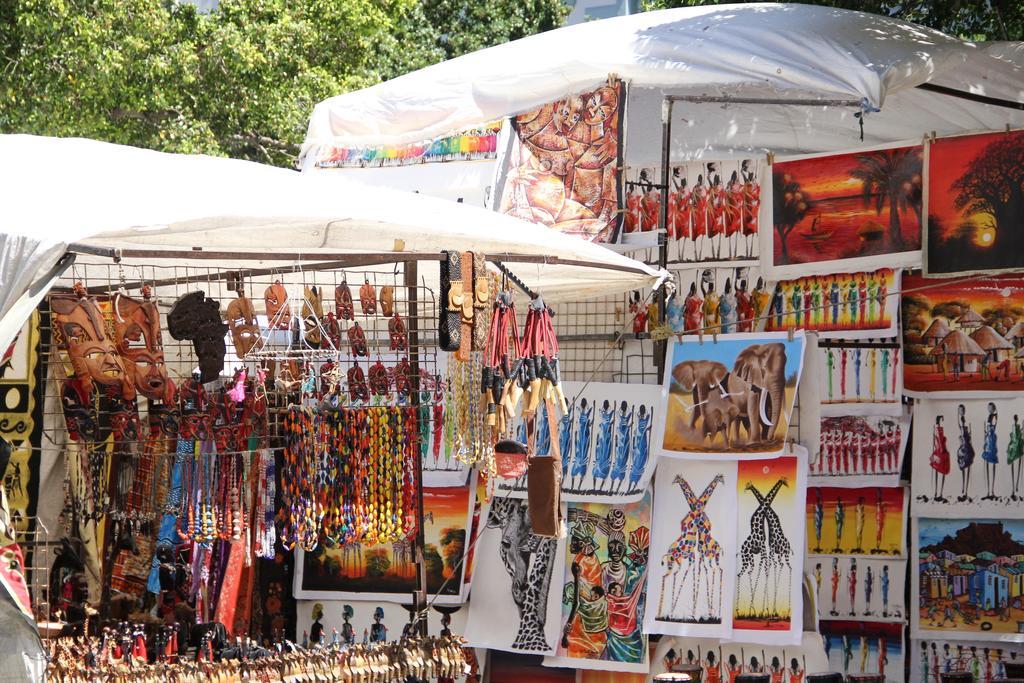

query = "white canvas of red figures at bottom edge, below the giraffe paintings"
[{"left": 650, "top": 632, "right": 828, "bottom": 683}]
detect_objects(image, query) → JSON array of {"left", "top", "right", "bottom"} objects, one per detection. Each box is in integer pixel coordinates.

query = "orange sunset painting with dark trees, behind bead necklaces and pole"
[{"left": 295, "top": 481, "right": 476, "bottom": 604}]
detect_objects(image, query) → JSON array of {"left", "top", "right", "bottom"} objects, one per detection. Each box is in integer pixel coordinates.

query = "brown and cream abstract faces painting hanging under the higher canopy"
[{"left": 498, "top": 81, "right": 626, "bottom": 242}]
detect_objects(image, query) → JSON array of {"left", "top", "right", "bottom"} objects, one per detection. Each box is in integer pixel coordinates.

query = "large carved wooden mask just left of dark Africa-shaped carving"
[{"left": 114, "top": 288, "right": 174, "bottom": 403}]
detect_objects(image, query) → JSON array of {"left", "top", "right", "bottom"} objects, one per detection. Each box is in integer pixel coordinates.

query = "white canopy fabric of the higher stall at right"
[{"left": 303, "top": 3, "right": 1024, "bottom": 163}]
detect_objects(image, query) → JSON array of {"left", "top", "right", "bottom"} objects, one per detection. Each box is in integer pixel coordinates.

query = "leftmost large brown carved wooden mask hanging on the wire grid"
[{"left": 50, "top": 289, "right": 135, "bottom": 400}]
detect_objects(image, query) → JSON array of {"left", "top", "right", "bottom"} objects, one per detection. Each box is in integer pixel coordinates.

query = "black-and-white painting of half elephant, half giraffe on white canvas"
[{"left": 466, "top": 496, "right": 565, "bottom": 654}]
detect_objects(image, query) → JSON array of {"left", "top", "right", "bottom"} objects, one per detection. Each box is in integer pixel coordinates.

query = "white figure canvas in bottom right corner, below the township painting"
[{"left": 909, "top": 638, "right": 1024, "bottom": 683}]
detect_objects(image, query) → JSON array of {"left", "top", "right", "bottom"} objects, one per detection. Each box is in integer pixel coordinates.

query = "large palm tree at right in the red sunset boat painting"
[{"left": 850, "top": 147, "right": 923, "bottom": 247}]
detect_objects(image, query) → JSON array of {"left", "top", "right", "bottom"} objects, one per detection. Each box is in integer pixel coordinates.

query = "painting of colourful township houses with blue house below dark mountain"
[{"left": 910, "top": 517, "right": 1024, "bottom": 641}]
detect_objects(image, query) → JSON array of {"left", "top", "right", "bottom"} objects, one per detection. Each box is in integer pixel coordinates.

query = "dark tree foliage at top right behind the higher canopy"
[{"left": 643, "top": 0, "right": 1024, "bottom": 40}]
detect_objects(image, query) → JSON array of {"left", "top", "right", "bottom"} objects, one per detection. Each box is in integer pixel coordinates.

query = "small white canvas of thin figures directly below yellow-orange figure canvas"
[{"left": 804, "top": 555, "right": 906, "bottom": 623}]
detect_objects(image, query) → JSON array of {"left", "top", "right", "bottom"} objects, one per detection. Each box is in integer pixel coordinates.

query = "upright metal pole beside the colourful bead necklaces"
[{"left": 402, "top": 260, "right": 427, "bottom": 638}]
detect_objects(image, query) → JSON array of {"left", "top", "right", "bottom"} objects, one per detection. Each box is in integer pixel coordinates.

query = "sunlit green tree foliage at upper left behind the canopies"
[{"left": 0, "top": 0, "right": 564, "bottom": 166}]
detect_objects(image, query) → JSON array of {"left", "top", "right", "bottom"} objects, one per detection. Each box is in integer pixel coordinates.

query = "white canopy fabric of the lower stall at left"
[{"left": 0, "top": 135, "right": 659, "bottom": 356}]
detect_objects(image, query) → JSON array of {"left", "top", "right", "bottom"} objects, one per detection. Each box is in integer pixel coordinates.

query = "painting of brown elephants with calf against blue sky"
[{"left": 654, "top": 333, "right": 805, "bottom": 458}]
